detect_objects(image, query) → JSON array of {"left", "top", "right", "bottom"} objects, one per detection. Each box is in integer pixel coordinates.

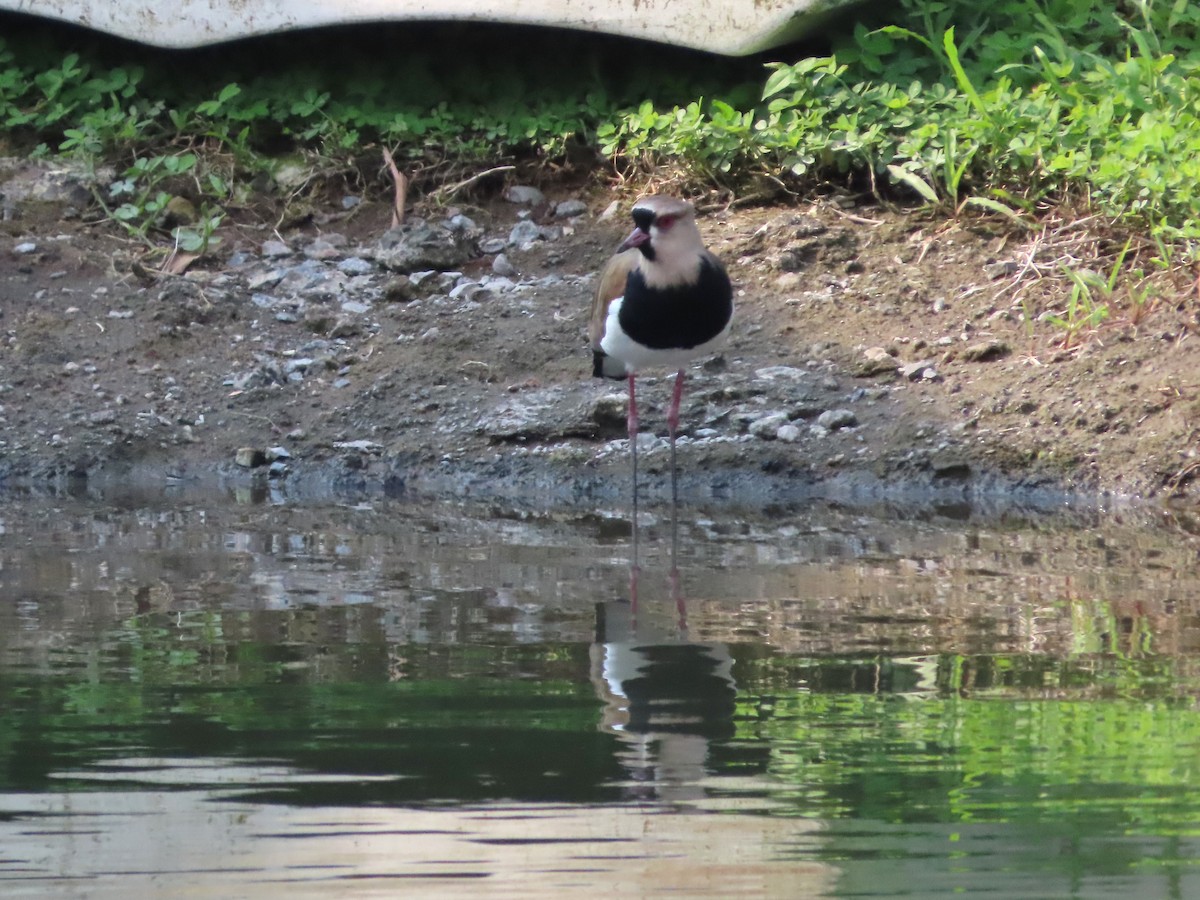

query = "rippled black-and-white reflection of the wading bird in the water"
[{"left": 592, "top": 569, "right": 737, "bottom": 800}]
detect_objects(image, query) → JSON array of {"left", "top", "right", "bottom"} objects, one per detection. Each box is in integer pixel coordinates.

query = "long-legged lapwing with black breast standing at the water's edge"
[{"left": 588, "top": 194, "right": 733, "bottom": 565}]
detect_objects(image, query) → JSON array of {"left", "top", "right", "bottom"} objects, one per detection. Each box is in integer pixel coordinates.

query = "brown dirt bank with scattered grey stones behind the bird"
[{"left": 0, "top": 161, "right": 1200, "bottom": 513}]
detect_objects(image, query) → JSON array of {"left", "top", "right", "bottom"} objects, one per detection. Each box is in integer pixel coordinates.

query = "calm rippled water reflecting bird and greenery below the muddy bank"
[{"left": 0, "top": 496, "right": 1200, "bottom": 898}]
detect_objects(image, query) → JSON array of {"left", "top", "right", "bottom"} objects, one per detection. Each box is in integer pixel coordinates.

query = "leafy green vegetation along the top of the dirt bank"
[{"left": 0, "top": 0, "right": 1200, "bottom": 336}]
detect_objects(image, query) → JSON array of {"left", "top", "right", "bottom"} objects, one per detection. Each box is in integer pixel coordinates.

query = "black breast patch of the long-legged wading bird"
[{"left": 618, "top": 256, "right": 733, "bottom": 350}]
